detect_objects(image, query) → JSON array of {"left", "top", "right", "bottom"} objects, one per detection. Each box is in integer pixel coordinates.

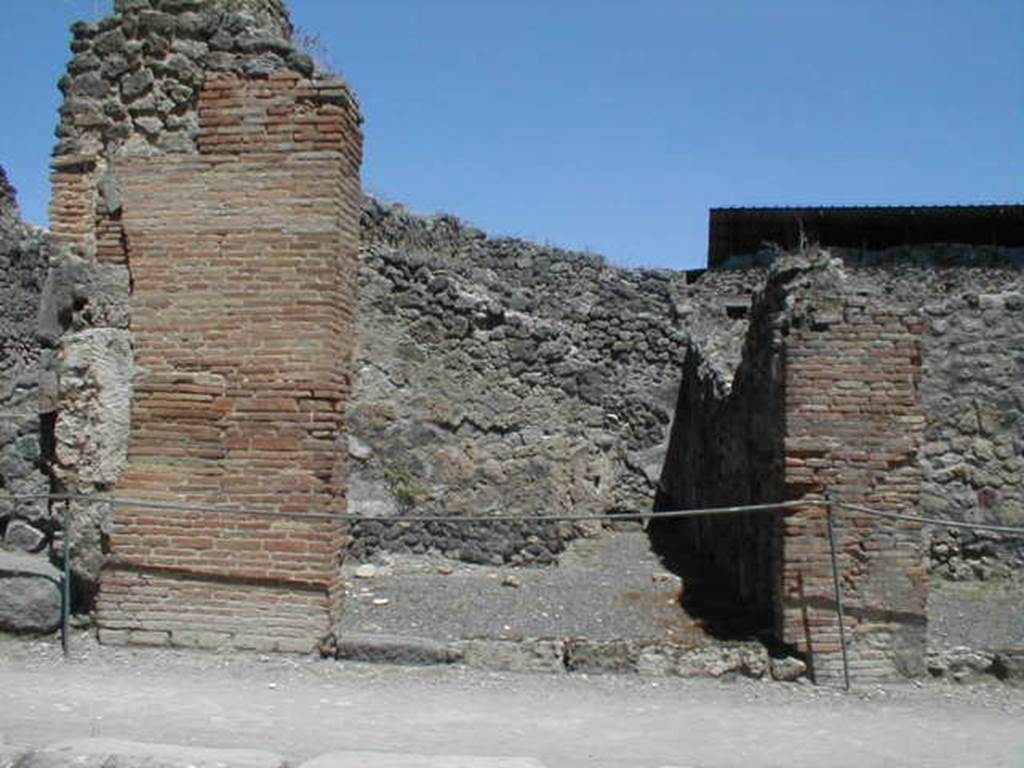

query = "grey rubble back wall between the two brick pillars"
[{"left": 350, "top": 201, "right": 753, "bottom": 563}]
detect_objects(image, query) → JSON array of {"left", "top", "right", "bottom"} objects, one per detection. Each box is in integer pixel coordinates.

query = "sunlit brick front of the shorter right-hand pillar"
[{"left": 781, "top": 288, "right": 927, "bottom": 680}]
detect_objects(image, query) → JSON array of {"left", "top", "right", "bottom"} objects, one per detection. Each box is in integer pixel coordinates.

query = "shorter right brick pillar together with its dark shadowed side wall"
[{"left": 650, "top": 254, "right": 927, "bottom": 680}]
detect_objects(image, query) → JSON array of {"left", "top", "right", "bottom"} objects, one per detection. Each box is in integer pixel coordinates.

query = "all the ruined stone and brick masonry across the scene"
[{"left": 0, "top": 0, "right": 1024, "bottom": 674}]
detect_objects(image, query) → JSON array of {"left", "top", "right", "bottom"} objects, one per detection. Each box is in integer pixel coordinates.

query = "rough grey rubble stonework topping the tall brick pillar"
[{"left": 54, "top": 0, "right": 357, "bottom": 170}]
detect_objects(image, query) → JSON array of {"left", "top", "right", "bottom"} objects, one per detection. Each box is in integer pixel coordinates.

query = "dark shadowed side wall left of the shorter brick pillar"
[{"left": 647, "top": 276, "right": 785, "bottom": 643}]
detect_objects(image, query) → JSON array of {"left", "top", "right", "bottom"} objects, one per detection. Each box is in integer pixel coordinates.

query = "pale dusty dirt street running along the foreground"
[{"left": 0, "top": 633, "right": 1024, "bottom": 768}]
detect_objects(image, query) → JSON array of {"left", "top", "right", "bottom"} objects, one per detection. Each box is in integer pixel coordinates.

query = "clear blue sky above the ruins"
[{"left": 0, "top": 0, "right": 1024, "bottom": 268}]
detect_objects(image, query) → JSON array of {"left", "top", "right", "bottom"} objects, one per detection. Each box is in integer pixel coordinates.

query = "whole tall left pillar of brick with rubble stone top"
[{"left": 44, "top": 0, "right": 361, "bottom": 650}]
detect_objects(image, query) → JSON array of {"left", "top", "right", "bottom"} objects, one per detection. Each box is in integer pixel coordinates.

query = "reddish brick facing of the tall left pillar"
[{"left": 98, "top": 73, "right": 361, "bottom": 650}]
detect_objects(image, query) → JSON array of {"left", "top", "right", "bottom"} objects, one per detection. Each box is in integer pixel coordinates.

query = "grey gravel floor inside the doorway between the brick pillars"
[{"left": 342, "top": 531, "right": 705, "bottom": 644}]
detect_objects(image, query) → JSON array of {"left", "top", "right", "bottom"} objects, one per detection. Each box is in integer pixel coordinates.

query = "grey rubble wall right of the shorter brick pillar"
[{"left": 823, "top": 256, "right": 1024, "bottom": 580}]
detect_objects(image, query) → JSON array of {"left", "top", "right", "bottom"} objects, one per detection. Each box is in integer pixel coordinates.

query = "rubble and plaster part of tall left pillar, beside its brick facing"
[{"left": 40, "top": 0, "right": 335, "bottom": 606}]
